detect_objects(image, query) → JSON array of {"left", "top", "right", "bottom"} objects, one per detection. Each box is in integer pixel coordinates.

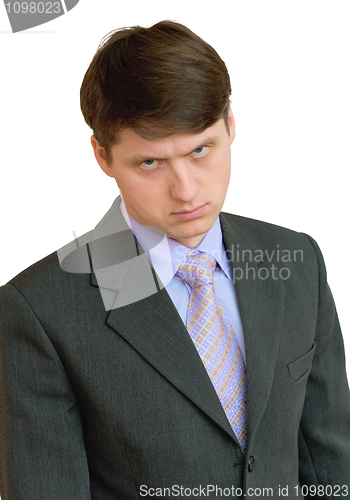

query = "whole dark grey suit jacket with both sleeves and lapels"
[{"left": 0, "top": 197, "right": 350, "bottom": 500}]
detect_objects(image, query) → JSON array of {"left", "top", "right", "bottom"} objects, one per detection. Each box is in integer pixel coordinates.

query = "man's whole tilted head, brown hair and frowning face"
[{"left": 81, "top": 21, "right": 235, "bottom": 248}]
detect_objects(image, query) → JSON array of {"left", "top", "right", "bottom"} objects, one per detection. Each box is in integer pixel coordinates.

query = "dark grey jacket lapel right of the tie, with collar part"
[{"left": 220, "top": 214, "right": 285, "bottom": 443}]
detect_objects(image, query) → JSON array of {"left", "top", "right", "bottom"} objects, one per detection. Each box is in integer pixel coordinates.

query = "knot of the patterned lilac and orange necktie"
[{"left": 176, "top": 250, "right": 216, "bottom": 288}]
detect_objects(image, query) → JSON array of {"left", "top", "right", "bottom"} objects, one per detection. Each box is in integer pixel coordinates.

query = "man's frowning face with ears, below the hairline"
[{"left": 92, "top": 110, "right": 235, "bottom": 248}]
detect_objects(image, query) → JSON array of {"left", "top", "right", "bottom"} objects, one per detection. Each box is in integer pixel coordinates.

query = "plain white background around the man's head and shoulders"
[{"left": 0, "top": 0, "right": 350, "bottom": 386}]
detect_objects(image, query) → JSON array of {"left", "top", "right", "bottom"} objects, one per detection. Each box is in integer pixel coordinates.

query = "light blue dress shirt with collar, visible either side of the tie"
[{"left": 120, "top": 201, "right": 246, "bottom": 361}]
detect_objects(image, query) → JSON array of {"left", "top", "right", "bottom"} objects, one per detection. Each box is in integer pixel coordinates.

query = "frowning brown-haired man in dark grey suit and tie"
[{"left": 0, "top": 22, "right": 350, "bottom": 500}]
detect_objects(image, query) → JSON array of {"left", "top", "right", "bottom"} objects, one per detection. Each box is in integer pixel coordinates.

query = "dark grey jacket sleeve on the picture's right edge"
[{"left": 299, "top": 237, "right": 350, "bottom": 498}]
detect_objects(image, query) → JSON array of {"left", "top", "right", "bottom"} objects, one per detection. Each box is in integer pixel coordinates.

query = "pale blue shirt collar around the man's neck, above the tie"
[{"left": 120, "top": 201, "right": 232, "bottom": 286}]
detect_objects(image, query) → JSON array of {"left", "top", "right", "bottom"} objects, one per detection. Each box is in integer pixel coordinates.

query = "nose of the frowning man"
[{"left": 169, "top": 159, "right": 199, "bottom": 202}]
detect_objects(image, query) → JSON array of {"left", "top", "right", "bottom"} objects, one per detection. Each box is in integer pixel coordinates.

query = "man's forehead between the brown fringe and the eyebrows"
[{"left": 111, "top": 119, "right": 227, "bottom": 162}]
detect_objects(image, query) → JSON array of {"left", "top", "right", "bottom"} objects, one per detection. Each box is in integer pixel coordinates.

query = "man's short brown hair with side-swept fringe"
[{"left": 80, "top": 21, "right": 231, "bottom": 162}]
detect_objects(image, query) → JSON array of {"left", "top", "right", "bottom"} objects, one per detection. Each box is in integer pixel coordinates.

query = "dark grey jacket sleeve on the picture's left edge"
[{"left": 0, "top": 285, "right": 91, "bottom": 500}]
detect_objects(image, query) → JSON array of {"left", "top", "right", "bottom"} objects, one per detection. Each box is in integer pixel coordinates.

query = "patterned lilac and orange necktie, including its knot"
[{"left": 176, "top": 250, "right": 247, "bottom": 452}]
